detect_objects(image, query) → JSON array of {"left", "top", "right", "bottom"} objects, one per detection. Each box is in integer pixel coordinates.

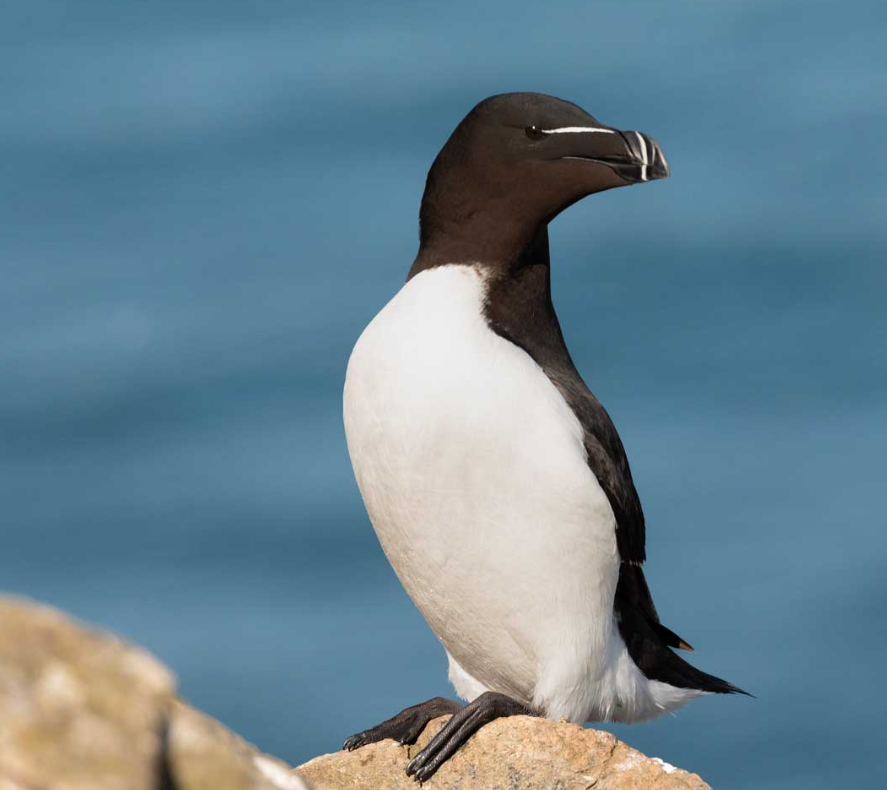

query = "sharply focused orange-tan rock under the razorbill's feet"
[{"left": 296, "top": 716, "right": 711, "bottom": 790}]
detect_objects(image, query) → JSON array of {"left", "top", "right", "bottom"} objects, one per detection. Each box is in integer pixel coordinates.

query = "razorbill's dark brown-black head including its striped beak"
[{"left": 414, "top": 93, "right": 668, "bottom": 268}]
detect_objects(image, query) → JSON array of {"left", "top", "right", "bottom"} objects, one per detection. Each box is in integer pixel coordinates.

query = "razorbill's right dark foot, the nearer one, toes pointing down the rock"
[{"left": 407, "top": 691, "right": 538, "bottom": 783}]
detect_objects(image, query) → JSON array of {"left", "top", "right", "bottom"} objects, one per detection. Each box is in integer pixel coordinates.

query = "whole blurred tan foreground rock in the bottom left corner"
[{"left": 0, "top": 598, "right": 306, "bottom": 790}]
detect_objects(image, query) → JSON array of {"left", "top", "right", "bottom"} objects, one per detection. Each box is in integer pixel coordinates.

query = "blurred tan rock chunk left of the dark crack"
[{"left": 0, "top": 598, "right": 175, "bottom": 790}]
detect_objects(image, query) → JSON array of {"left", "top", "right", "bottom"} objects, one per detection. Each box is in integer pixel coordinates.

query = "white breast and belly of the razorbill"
[{"left": 344, "top": 266, "right": 692, "bottom": 721}]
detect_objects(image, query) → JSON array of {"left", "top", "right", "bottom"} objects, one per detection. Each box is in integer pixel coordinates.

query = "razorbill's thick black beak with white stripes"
[{"left": 560, "top": 127, "right": 669, "bottom": 184}]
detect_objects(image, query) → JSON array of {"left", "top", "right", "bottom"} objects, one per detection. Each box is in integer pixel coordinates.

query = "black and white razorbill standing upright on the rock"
[{"left": 344, "top": 93, "right": 744, "bottom": 781}]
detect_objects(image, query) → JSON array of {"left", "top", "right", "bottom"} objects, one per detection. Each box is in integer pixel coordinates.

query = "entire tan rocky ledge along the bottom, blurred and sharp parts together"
[{"left": 0, "top": 598, "right": 710, "bottom": 790}]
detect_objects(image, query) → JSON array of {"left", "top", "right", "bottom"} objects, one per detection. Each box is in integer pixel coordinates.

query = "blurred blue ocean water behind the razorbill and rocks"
[{"left": 0, "top": 0, "right": 887, "bottom": 790}]
